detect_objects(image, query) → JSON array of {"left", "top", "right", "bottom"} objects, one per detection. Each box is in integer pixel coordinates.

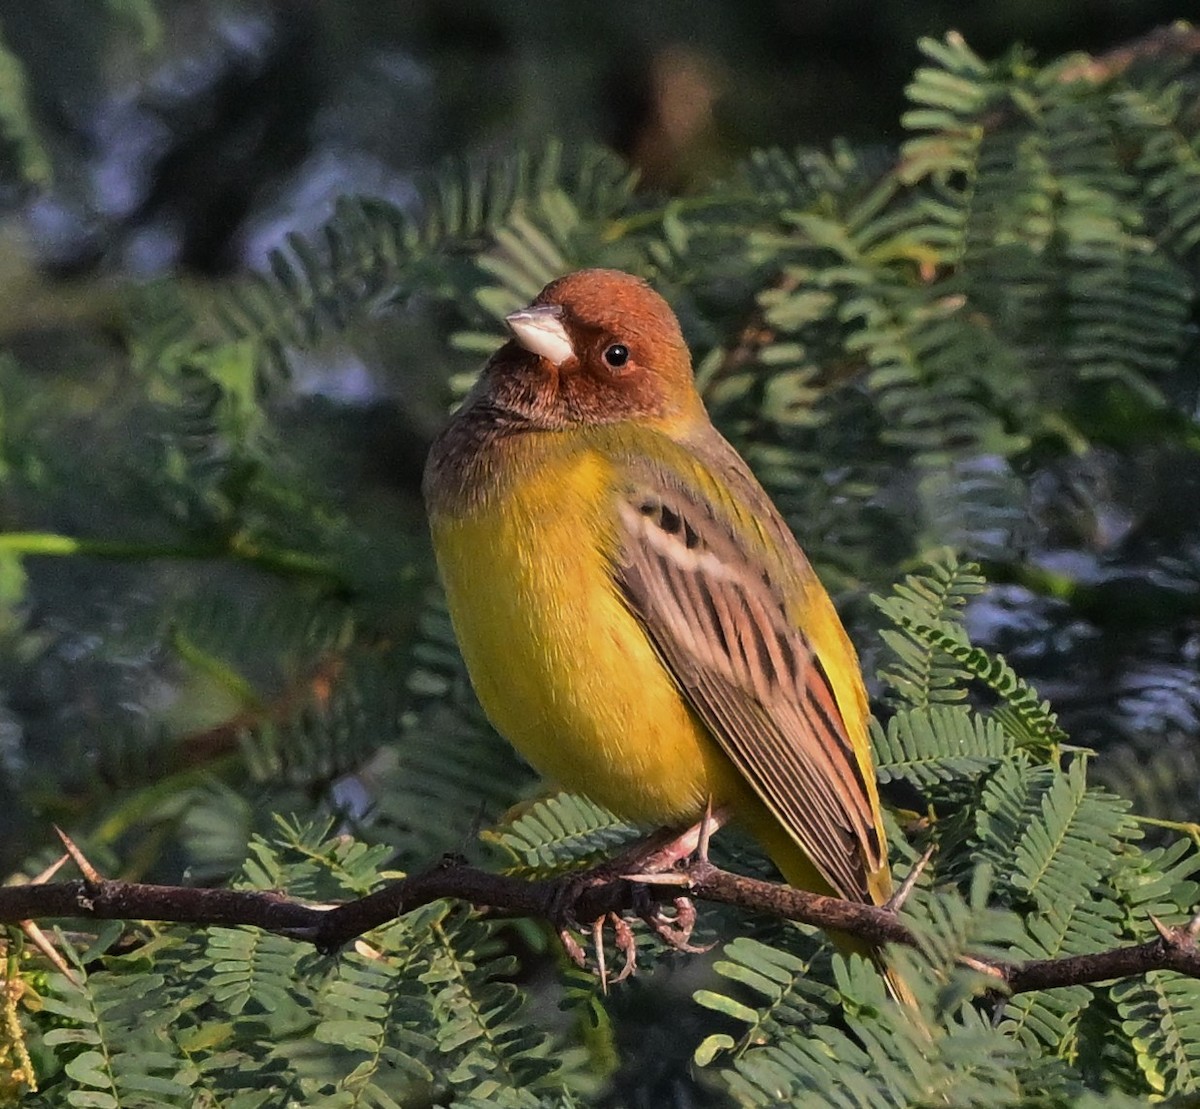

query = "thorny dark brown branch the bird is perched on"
[{"left": 0, "top": 841, "right": 1200, "bottom": 994}]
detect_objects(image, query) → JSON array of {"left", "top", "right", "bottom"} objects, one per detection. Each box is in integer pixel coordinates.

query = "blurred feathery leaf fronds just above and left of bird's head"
[{"left": 208, "top": 142, "right": 634, "bottom": 374}]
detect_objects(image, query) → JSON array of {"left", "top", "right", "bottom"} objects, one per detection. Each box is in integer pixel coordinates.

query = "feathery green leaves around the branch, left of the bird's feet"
[{"left": 22, "top": 822, "right": 580, "bottom": 1107}]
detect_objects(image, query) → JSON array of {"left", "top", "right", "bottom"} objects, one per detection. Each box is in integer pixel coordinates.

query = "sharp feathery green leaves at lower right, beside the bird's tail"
[{"left": 696, "top": 556, "right": 1200, "bottom": 1105}]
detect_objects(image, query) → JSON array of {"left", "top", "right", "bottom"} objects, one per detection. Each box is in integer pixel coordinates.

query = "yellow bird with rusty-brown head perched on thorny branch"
[{"left": 422, "top": 269, "right": 907, "bottom": 996}]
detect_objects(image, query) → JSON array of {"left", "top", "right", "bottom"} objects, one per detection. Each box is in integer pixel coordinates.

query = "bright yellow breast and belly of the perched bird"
[{"left": 431, "top": 441, "right": 749, "bottom": 825}]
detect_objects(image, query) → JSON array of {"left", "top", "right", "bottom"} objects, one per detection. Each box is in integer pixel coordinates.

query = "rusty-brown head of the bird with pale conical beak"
[{"left": 481, "top": 270, "right": 703, "bottom": 428}]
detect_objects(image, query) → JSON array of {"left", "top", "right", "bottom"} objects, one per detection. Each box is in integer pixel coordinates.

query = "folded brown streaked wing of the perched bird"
[{"left": 616, "top": 458, "right": 883, "bottom": 900}]
